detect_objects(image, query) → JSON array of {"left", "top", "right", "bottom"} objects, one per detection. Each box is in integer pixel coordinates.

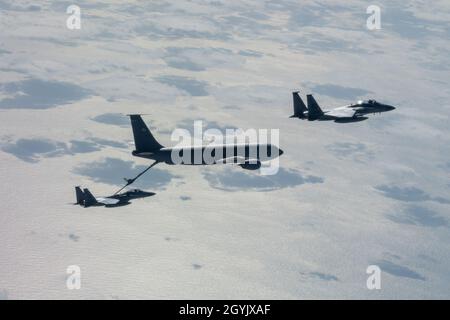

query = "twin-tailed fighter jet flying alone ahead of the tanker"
[{"left": 291, "top": 92, "right": 395, "bottom": 122}]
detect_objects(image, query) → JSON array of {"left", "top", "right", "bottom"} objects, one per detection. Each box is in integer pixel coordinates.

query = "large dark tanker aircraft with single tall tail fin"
[{"left": 127, "top": 114, "right": 283, "bottom": 170}]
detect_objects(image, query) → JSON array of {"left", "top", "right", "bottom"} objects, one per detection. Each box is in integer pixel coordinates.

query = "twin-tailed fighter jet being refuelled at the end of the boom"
[{"left": 75, "top": 187, "right": 155, "bottom": 208}]
